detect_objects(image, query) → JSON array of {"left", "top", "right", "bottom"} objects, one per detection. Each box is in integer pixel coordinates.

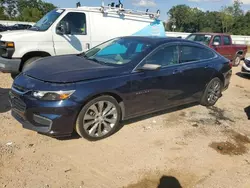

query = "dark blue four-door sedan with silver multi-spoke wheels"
[{"left": 10, "top": 37, "right": 232, "bottom": 141}]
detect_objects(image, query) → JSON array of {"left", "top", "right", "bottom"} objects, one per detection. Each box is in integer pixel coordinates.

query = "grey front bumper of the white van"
[{"left": 0, "top": 57, "right": 21, "bottom": 73}]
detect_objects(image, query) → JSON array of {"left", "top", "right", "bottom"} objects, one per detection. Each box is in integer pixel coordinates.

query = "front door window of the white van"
[{"left": 61, "top": 12, "right": 87, "bottom": 35}]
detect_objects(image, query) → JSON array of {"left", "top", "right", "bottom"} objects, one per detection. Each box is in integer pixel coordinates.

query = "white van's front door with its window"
[{"left": 53, "top": 12, "right": 91, "bottom": 55}]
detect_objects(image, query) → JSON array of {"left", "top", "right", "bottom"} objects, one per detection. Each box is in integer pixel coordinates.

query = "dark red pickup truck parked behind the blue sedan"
[{"left": 187, "top": 33, "right": 247, "bottom": 66}]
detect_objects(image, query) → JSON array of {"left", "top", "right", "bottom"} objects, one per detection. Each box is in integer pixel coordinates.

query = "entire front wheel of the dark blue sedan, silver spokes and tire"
[{"left": 76, "top": 96, "right": 121, "bottom": 141}]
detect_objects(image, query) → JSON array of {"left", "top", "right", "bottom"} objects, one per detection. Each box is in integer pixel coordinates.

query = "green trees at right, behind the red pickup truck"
[{"left": 166, "top": 0, "right": 250, "bottom": 35}]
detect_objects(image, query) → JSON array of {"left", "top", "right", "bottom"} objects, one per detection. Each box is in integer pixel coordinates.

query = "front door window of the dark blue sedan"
[{"left": 144, "top": 46, "right": 179, "bottom": 67}]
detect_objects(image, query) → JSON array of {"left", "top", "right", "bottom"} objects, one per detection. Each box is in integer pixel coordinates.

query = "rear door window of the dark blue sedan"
[{"left": 180, "top": 46, "right": 215, "bottom": 63}]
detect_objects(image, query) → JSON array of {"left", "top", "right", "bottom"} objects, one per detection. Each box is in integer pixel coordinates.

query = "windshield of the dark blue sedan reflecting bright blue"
[{"left": 84, "top": 38, "right": 151, "bottom": 65}]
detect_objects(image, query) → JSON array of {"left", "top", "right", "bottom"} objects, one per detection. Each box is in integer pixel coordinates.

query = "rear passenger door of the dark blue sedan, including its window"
[{"left": 176, "top": 44, "right": 216, "bottom": 103}]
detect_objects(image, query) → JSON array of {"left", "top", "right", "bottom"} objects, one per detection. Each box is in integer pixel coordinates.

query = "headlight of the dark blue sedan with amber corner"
[{"left": 32, "top": 90, "right": 75, "bottom": 101}]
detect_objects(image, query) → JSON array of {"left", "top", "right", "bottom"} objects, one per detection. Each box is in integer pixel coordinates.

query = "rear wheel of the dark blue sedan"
[{"left": 200, "top": 77, "right": 222, "bottom": 106}]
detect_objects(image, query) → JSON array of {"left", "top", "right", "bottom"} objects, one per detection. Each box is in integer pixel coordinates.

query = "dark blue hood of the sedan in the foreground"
[{"left": 23, "top": 55, "right": 126, "bottom": 83}]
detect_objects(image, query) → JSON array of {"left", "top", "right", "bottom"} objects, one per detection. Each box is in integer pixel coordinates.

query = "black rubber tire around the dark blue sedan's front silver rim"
[{"left": 75, "top": 95, "right": 122, "bottom": 141}]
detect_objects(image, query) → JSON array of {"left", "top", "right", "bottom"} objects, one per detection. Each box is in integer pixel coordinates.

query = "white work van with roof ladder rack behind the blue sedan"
[{"left": 0, "top": 4, "right": 165, "bottom": 77}]
